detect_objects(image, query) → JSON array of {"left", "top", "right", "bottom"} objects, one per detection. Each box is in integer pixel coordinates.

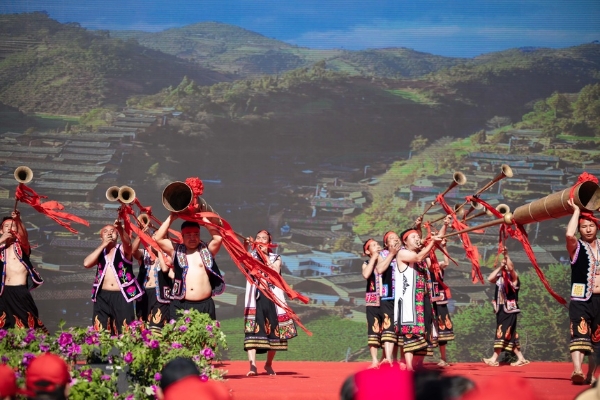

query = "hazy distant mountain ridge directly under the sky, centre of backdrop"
[{"left": 110, "top": 22, "right": 466, "bottom": 78}]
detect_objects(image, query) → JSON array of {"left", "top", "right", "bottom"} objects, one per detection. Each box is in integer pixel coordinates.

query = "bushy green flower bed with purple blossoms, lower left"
[{"left": 0, "top": 310, "right": 227, "bottom": 399}]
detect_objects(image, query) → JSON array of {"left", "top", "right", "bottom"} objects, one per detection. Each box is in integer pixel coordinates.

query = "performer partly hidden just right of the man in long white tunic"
[{"left": 428, "top": 239, "right": 454, "bottom": 367}]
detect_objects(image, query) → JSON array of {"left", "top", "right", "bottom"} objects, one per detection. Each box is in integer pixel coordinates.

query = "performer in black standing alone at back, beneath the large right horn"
[{"left": 482, "top": 247, "right": 529, "bottom": 367}]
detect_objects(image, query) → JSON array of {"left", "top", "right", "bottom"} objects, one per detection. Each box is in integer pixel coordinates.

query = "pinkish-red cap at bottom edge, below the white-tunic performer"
[{"left": 354, "top": 364, "right": 415, "bottom": 400}]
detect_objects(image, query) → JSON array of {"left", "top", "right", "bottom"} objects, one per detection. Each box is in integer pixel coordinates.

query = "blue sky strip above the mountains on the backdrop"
[{"left": 0, "top": 0, "right": 600, "bottom": 57}]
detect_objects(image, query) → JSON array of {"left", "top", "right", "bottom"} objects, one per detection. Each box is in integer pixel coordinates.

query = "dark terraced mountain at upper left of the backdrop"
[{"left": 0, "top": 12, "right": 231, "bottom": 115}]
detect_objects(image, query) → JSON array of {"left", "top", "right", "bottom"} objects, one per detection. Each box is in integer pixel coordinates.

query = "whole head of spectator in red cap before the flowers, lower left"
[{"left": 25, "top": 353, "right": 71, "bottom": 400}]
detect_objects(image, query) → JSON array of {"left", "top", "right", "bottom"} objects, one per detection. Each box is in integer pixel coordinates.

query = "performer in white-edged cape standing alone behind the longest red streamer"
[{"left": 244, "top": 230, "right": 298, "bottom": 376}]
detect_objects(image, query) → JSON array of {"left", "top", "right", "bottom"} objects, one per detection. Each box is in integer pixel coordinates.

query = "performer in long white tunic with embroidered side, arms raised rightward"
[{"left": 394, "top": 224, "right": 446, "bottom": 371}]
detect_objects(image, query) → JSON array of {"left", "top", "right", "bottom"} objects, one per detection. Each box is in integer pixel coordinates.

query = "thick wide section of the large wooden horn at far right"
[{"left": 513, "top": 181, "right": 600, "bottom": 225}]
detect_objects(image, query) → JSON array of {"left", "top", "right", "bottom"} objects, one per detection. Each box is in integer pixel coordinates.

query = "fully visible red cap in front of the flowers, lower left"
[{"left": 25, "top": 353, "right": 71, "bottom": 393}]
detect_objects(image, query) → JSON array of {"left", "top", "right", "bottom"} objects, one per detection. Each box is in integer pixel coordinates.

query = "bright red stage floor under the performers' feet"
[{"left": 216, "top": 360, "right": 588, "bottom": 400}]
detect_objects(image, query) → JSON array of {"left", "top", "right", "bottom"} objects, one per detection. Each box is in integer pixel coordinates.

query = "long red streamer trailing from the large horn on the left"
[{"left": 177, "top": 207, "right": 312, "bottom": 336}]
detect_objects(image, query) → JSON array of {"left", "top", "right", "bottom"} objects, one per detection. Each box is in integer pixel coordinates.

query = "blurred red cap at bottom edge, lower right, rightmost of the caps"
[{"left": 462, "top": 373, "right": 539, "bottom": 400}]
